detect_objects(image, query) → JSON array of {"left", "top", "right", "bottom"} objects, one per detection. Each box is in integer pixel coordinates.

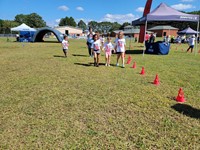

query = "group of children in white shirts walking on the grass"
[{"left": 62, "top": 29, "right": 126, "bottom": 68}]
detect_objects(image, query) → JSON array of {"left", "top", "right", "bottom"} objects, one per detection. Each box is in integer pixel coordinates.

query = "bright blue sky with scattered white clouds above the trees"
[{"left": 0, "top": 0, "right": 200, "bottom": 27}]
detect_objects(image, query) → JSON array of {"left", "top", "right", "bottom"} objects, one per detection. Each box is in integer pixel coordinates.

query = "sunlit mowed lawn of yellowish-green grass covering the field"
[{"left": 0, "top": 38, "right": 200, "bottom": 150}]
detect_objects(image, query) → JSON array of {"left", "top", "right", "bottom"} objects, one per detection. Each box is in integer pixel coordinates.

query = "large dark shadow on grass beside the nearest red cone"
[{"left": 171, "top": 104, "right": 200, "bottom": 119}]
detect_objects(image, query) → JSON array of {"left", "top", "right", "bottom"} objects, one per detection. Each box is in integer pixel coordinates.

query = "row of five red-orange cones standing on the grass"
[{"left": 126, "top": 56, "right": 185, "bottom": 103}]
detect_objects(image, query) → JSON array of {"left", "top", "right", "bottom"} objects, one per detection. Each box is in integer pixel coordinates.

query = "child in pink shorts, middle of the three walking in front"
[{"left": 103, "top": 37, "right": 114, "bottom": 66}]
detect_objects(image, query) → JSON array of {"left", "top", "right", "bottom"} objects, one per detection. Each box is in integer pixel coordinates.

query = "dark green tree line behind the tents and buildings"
[{"left": 0, "top": 10, "right": 200, "bottom": 34}]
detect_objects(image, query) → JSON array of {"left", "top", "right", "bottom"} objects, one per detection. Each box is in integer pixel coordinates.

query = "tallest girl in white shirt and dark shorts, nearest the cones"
[{"left": 115, "top": 31, "right": 126, "bottom": 68}]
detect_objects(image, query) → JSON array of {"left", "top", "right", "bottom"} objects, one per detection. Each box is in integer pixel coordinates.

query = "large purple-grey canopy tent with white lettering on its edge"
[{"left": 132, "top": 3, "right": 199, "bottom": 55}]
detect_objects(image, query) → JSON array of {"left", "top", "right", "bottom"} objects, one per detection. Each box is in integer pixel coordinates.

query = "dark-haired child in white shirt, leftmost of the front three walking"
[{"left": 91, "top": 34, "right": 101, "bottom": 67}]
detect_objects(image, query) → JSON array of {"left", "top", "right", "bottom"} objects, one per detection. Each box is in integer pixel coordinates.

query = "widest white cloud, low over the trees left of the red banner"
[{"left": 102, "top": 13, "right": 138, "bottom": 23}]
